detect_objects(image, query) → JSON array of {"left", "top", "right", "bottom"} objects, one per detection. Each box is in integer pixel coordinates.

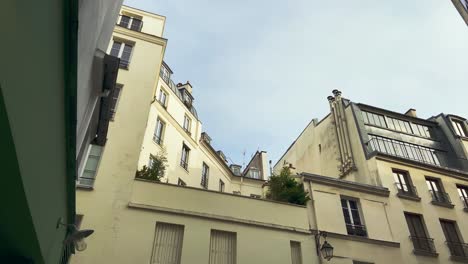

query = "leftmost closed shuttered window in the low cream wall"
[{"left": 151, "top": 222, "right": 184, "bottom": 264}]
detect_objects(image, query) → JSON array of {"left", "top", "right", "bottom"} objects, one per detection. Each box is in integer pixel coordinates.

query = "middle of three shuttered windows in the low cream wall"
[{"left": 209, "top": 230, "right": 237, "bottom": 264}]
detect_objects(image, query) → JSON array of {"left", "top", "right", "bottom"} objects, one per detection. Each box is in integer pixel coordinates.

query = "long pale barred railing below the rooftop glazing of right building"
[{"left": 367, "top": 135, "right": 440, "bottom": 166}]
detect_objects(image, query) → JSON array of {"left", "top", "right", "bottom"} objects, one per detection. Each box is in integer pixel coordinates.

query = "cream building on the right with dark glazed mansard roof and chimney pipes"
[{"left": 274, "top": 90, "right": 468, "bottom": 263}]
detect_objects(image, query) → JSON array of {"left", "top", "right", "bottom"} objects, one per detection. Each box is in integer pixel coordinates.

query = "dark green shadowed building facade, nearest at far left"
[{"left": 0, "top": 0, "right": 122, "bottom": 263}]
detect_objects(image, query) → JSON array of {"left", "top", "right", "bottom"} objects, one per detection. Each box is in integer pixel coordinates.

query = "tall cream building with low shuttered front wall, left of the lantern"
[{"left": 71, "top": 6, "right": 317, "bottom": 264}]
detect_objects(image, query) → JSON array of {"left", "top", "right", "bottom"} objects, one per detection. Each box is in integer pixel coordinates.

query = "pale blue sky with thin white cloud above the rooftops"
[{"left": 125, "top": 0, "right": 468, "bottom": 167}]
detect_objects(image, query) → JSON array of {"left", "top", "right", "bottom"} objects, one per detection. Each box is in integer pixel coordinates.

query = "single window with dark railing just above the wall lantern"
[{"left": 341, "top": 198, "right": 367, "bottom": 236}]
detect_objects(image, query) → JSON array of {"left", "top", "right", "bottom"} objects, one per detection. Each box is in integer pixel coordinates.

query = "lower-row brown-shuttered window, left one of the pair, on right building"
[{"left": 405, "top": 213, "right": 435, "bottom": 253}]
